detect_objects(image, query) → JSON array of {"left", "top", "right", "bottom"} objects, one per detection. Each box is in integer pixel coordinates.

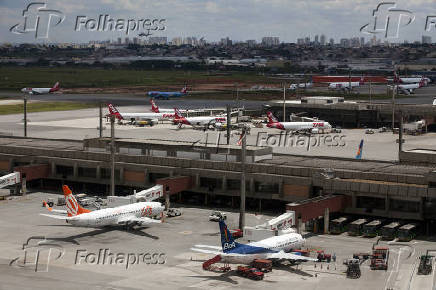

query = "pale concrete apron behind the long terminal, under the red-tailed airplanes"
[{"left": 0, "top": 106, "right": 436, "bottom": 161}]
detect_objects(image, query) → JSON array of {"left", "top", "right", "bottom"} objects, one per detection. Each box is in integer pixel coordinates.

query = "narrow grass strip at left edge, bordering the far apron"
[{"left": 0, "top": 102, "right": 97, "bottom": 115}]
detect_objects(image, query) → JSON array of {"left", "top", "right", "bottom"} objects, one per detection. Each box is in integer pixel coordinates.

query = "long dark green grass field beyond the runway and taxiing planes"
[{"left": 0, "top": 67, "right": 271, "bottom": 90}]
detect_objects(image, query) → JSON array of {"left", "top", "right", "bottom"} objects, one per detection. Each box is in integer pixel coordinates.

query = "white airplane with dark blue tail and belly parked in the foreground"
[{"left": 191, "top": 220, "right": 318, "bottom": 264}]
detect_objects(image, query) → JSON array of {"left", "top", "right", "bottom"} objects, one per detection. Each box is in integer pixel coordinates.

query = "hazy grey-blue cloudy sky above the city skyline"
[{"left": 0, "top": 0, "right": 436, "bottom": 43}]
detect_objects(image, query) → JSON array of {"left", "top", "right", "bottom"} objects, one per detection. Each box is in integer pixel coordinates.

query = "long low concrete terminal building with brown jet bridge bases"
[{"left": 0, "top": 137, "right": 436, "bottom": 232}]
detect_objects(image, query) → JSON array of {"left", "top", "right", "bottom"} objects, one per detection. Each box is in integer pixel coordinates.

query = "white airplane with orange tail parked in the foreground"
[{"left": 40, "top": 185, "right": 164, "bottom": 228}]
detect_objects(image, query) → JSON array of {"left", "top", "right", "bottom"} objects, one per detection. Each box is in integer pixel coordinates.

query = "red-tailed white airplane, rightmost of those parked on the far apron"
[{"left": 266, "top": 112, "right": 332, "bottom": 133}]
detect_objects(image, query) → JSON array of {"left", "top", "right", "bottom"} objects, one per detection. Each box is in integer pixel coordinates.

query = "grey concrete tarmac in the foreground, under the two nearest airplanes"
[{"left": 0, "top": 192, "right": 435, "bottom": 290}]
